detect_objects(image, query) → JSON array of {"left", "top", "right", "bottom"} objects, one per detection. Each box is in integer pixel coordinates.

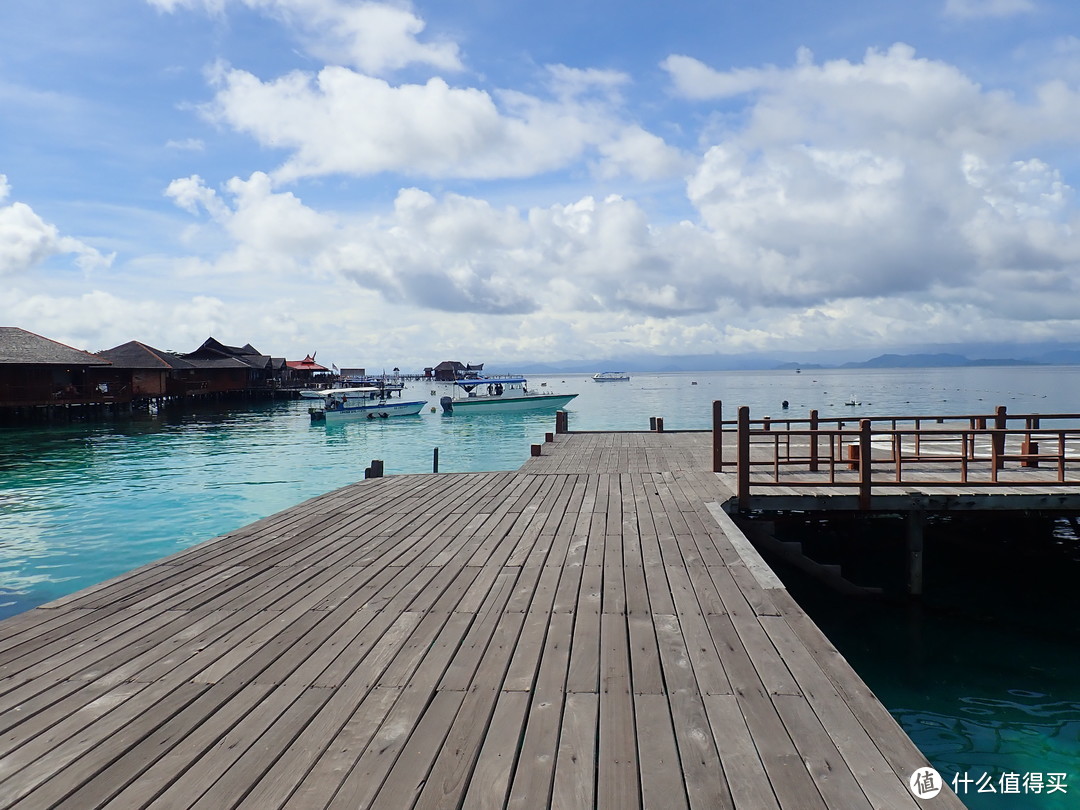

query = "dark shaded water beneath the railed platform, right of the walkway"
[{"left": 768, "top": 515, "right": 1080, "bottom": 810}]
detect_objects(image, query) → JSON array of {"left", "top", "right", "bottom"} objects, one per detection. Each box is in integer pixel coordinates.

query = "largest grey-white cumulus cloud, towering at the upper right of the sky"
[{"left": 664, "top": 45, "right": 1080, "bottom": 321}]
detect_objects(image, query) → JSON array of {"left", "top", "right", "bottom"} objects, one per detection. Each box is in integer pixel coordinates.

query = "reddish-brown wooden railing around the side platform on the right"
[{"left": 713, "top": 402, "right": 1080, "bottom": 509}]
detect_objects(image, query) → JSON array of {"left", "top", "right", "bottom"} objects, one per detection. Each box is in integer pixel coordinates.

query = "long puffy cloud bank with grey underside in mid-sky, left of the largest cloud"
[{"left": 166, "top": 173, "right": 719, "bottom": 316}]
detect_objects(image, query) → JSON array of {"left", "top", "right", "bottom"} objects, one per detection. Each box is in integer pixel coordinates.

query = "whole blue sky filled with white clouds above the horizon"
[{"left": 0, "top": 0, "right": 1080, "bottom": 368}]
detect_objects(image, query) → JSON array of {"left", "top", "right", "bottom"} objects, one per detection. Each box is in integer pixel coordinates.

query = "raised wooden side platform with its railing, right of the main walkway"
[{"left": 712, "top": 402, "right": 1080, "bottom": 512}]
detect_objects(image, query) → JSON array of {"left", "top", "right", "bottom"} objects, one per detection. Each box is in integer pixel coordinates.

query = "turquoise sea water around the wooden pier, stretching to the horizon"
[{"left": 0, "top": 367, "right": 1080, "bottom": 808}]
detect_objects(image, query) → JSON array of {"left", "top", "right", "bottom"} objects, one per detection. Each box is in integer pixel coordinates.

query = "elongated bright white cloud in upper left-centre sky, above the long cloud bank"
[{"left": 198, "top": 66, "right": 683, "bottom": 181}]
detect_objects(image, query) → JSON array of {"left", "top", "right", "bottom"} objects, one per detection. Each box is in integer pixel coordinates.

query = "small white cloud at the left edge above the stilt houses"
[{"left": 0, "top": 174, "right": 112, "bottom": 276}]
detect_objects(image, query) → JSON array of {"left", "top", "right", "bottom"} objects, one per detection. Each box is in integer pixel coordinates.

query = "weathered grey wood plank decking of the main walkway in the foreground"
[{"left": 0, "top": 433, "right": 962, "bottom": 810}]
